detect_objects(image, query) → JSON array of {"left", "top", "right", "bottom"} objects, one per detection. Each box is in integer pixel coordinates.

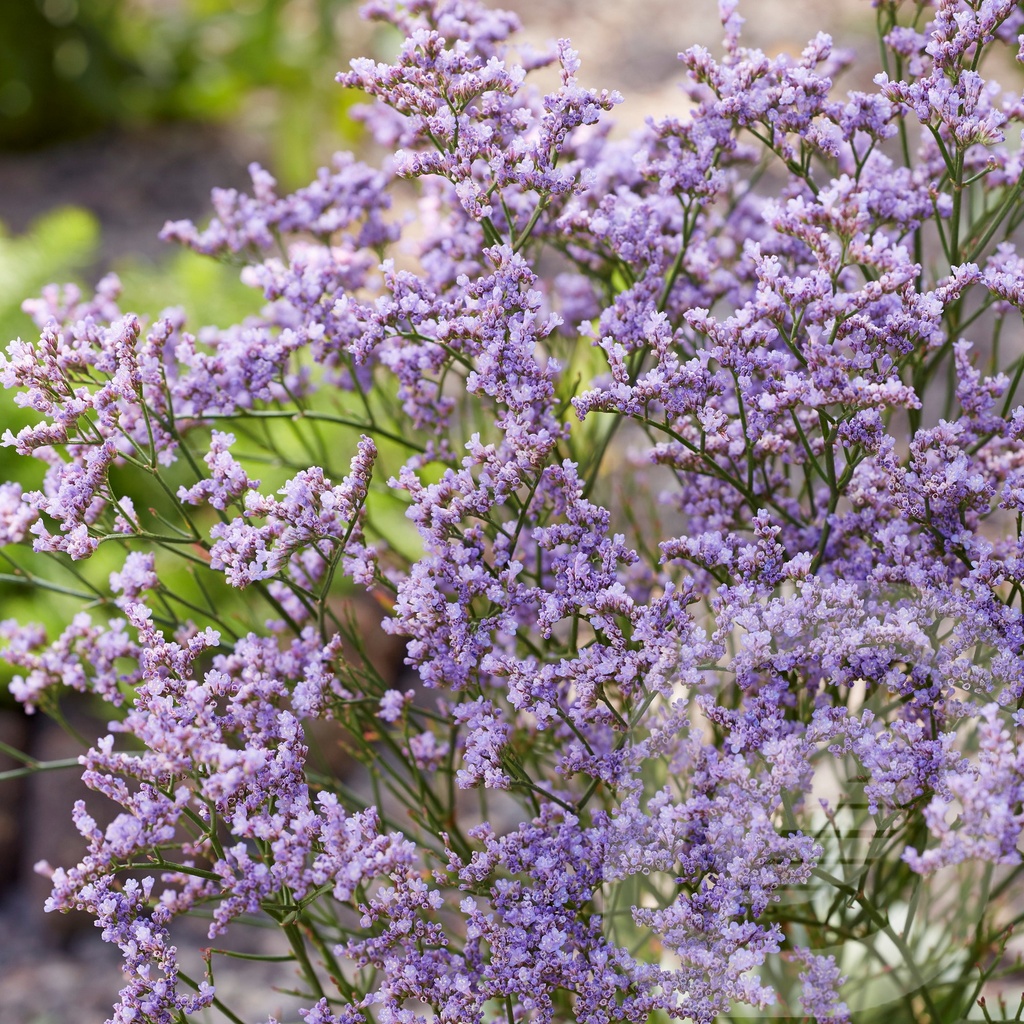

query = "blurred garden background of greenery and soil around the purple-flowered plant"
[{"left": 0, "top": 0, "right": 888, "bottom": 1024}]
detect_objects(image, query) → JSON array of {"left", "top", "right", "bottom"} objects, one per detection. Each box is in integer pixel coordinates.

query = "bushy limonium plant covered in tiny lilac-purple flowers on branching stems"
[{"left": 0, "top": 0, "right": 1024, "bottom": 1024}]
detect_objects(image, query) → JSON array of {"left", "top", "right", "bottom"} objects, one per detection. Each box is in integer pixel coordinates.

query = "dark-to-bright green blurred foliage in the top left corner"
[{"left": 0, "top": 0, "right": 362, "bottom": 185}]
